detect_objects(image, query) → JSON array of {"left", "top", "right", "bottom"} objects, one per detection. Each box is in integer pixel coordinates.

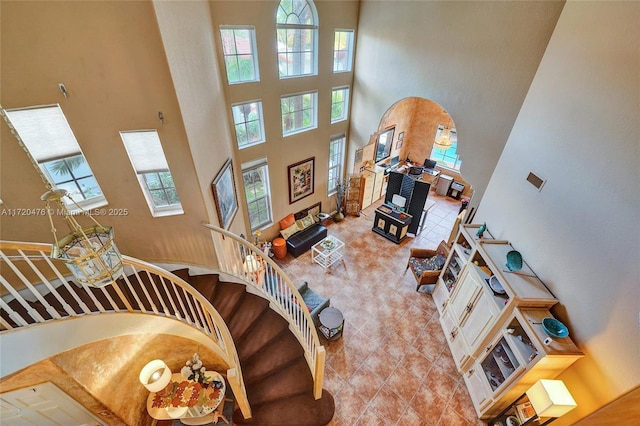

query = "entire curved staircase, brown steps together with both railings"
[{"left": 0, "top": 238, "right": 335, "bottom": 426}]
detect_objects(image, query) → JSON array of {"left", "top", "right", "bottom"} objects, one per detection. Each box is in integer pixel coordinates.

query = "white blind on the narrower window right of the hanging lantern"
[{"left": 120, "top": 130, "right": 169, "bottom": 173}]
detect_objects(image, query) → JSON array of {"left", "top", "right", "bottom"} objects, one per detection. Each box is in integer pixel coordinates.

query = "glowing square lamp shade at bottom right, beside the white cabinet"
[{"left": 527, "top": 379, "right": 578, "bottom": 417}]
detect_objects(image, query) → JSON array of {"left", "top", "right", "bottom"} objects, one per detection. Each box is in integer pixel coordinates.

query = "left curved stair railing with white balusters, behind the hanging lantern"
[{"left": 0, "top": 241, "right": 251, "bottom": 418}]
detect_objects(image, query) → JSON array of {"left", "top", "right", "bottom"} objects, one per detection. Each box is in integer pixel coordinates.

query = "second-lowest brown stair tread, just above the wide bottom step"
[{"left": 247, "top": 358, "right": 313, "bottom": 405}]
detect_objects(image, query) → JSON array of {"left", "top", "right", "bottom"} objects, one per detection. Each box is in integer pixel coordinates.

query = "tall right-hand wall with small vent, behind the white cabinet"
[{"left": 476, "top": 1, "right": 640, "bottom": 425}]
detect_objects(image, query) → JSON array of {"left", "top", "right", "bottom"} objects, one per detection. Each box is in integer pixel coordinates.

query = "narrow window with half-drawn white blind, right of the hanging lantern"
[{"left": 120, "top": 130, "right": 183, "bottom": 216}]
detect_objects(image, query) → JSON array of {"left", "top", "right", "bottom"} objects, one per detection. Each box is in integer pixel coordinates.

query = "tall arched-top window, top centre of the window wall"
[{"left": 276, "top": 0, "right": 318, "bottom": 78}]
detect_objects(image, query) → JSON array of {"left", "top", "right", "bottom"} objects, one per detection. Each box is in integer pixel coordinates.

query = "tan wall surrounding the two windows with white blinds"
[{"left": 0, "top": 1, "right": 215, "bottom": 266}]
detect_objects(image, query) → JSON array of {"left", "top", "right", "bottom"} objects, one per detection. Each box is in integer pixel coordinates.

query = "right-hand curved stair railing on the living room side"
[{"left": 204, "top": 224, "right": 326, "bottom": 399}]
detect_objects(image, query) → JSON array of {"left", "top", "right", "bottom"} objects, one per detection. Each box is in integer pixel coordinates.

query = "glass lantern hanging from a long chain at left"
[{"left": 0, "top": 106, "right": 123, "bottom": 287}]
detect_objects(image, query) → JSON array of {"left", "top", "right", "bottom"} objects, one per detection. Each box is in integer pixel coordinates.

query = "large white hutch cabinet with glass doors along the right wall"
[{"left": 433, "top": 225, "right": 583, "bottom": 419}]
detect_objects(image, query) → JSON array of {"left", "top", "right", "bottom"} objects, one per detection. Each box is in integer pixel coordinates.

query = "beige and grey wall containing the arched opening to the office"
[{"left": 349, "top": 1, "right": 564, "bottom": 210}]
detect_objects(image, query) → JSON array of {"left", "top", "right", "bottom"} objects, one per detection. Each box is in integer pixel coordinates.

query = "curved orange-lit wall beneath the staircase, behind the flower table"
[{"left": 0, "top": 334, "right": 228, "bottom": 426}]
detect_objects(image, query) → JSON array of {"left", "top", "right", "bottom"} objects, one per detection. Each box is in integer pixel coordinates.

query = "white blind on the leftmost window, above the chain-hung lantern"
[{"left": 6, "top": 105, "right": 81, "bottom": 163}]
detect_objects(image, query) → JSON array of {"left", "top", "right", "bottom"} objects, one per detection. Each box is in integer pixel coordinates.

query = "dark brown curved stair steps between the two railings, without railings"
[{"left": 178, "top": 270, "right": 335, "bottom": 426}]
